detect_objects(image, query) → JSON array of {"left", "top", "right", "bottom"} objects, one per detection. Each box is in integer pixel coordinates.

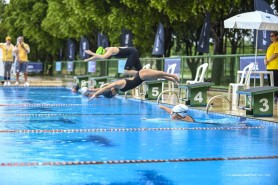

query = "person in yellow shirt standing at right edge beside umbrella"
[{"left": 264, "top": 31, "right": 278, "bottom": 102}]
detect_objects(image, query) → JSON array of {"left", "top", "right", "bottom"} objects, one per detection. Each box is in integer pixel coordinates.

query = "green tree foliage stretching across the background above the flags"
[{"left": 0, "top": 0, "right": 277, "bottom": 76}]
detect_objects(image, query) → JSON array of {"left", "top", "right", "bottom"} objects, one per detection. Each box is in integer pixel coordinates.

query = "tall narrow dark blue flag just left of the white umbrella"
[{"left": 197, "top": 13, "right": 210, "bottom": 53}]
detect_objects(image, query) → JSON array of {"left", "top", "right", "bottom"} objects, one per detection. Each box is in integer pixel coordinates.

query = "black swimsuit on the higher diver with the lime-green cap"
[{"left": 114, "top": 47, "right": 142, "bottom": 71}]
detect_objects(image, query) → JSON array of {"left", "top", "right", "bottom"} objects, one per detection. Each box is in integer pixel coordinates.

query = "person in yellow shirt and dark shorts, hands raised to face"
[{"left": 14, "top": 36, "right": 30, "bottom": 86}]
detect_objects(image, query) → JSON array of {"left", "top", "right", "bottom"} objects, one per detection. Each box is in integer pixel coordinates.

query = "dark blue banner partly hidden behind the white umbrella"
[{"left": 254, "top": 0, "right": 273, "bottom": 50}]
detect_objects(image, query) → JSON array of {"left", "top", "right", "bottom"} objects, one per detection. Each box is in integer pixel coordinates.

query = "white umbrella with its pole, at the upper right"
[{"left": 224, "top": 11, "right": 278, "bottom": 85}]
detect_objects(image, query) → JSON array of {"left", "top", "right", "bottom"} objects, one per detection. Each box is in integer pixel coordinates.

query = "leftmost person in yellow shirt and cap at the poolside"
[{"left": 0, "top": 36, "right": 14, "bottom": 86}]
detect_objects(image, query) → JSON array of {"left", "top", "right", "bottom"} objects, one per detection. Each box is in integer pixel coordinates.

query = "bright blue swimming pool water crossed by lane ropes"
[{"left": 0, "top": 87, "right": 278, "bottom": 185}]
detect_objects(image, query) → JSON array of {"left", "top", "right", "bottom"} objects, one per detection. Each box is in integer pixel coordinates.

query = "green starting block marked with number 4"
[{"left": 178, "top": 82, "right": 214, "bottom": 107}]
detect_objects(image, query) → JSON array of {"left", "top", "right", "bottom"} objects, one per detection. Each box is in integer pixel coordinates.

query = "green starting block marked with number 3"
[{"left": 237, "top": 86, "right": 278, "bottom": 117}]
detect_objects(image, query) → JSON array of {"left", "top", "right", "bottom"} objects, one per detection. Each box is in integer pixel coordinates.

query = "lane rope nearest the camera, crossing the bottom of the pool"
[{"left": 0, "top": 156, "right": 278, "bottom": 167}]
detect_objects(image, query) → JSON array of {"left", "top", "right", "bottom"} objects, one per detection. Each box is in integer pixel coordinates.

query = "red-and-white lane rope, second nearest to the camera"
[{"left": 0, "top": 126, "right": 264, "bottom": 133}]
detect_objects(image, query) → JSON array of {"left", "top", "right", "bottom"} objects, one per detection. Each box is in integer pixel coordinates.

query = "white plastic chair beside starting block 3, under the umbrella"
[{"left": 228, "top": 63, "right": 254, "bottom": 110}]
